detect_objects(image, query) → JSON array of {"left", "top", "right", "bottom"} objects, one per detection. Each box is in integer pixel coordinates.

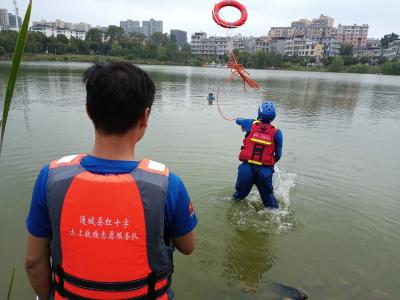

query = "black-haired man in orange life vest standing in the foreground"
[{"left": 25, "top": 63, "right": 197, "bottom": 299}]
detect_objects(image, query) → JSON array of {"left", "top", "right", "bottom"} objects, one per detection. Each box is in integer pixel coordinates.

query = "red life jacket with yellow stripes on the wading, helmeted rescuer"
[{"left": 239, "top": 121, "right": 278, "bottom": 166}]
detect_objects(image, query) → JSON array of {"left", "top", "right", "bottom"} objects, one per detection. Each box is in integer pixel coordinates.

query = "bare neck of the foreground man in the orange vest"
[{"left": 91, "top": 132, "right": 137, "bottom": 161}]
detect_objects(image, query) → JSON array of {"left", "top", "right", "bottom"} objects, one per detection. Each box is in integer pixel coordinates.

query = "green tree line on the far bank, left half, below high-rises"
[{"left": 0, "top": 26, "right": 191, "bottom": 63}]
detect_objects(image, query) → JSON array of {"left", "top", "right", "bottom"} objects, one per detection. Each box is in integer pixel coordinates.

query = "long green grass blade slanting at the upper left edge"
[{"left": 0, "top": 0, "right": 32, "bottom": 155}]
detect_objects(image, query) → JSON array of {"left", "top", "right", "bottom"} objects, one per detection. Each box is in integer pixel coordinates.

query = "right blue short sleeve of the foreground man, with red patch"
[{"left": 166, "top": 173, "right": 198, "bottom": 237}]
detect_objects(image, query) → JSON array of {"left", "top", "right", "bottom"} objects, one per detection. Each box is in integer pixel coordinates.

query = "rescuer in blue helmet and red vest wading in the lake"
[{"left": 233, "top": 102, "right": 283, "bottom": 208}]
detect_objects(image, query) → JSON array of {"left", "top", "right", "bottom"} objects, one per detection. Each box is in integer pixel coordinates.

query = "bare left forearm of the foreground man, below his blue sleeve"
[{"left": 25, "top": 233, "right": 51, "bottom": 299}]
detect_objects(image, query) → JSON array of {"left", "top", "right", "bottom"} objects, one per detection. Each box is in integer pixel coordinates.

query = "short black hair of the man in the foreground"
[{"left": 83, "top": 62, "right": 155, "bottom": 134}]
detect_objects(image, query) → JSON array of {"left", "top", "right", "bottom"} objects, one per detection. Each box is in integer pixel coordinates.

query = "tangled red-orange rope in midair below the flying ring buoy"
[{"left": 217, "top": 51, "right": 260, "bottom": 121}]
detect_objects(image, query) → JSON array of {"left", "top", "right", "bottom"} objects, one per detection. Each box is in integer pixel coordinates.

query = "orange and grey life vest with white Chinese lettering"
[{"left": 47, "top": 155, "right": 173, "bottom": 300}]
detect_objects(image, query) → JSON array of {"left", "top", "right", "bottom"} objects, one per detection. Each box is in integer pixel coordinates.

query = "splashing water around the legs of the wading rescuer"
[{"left": 228, "top": 167, "right": 299, "bottom": 235}]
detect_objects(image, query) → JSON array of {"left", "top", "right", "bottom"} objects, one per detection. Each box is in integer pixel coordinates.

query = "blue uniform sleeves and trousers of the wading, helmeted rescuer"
[{"left": 233, "top": 119, "right": 283, "bottom": 208}]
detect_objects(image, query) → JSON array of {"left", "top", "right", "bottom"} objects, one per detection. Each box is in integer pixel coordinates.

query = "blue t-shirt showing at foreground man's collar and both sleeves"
[{"left": 26, "top": 155, "right": 197, "bottom": 238}]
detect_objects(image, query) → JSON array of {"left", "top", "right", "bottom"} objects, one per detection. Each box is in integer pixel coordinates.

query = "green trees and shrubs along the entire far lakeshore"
[{"left": 0, "top": 26, "right": 400, "bottom": 75}]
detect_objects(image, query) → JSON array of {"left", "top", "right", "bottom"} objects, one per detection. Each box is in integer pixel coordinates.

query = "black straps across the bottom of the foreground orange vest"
[{"left": 53, "top": 265, "right": 173, "bottom": 294}]
